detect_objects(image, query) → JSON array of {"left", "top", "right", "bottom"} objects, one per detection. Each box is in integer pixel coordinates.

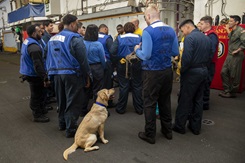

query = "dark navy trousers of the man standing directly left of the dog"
[{"left": 54, "top": 74, "right": 84, "bottom": 133}]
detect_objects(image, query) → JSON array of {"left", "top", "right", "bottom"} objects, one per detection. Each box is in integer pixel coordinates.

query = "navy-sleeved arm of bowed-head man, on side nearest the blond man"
[{"left": 180, "top": 36, "right": 194, "bottom": 74}]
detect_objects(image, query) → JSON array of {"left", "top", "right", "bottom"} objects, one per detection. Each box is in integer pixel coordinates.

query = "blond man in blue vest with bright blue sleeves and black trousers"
[{"left": 134, "top": 4, "right": 179, "bottom": 144}]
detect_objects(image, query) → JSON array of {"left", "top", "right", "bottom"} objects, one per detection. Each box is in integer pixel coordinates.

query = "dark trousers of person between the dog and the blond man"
[{"left": 116, "top": 62, "right": 143, "bottom": 113}]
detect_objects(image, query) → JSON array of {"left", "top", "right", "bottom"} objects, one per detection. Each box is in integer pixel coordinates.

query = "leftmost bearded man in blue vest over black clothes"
[{"left": 20, "top": 25, "right": 49, "bottom": 123}]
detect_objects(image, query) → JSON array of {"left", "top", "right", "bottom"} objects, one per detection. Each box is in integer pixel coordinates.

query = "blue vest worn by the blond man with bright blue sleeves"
[{"left": 142, "top": 21, "right": 176, "bottom": 70}]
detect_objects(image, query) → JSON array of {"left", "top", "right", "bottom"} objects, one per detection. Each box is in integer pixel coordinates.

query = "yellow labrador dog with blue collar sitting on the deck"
[{"left": 63, "top": 89, "right": 115, "bottom": 160}]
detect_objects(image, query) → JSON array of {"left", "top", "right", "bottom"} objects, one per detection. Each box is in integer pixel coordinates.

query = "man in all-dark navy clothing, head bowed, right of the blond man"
[{"left": 173, "top": 19, "right": 213, "bottom": 135}]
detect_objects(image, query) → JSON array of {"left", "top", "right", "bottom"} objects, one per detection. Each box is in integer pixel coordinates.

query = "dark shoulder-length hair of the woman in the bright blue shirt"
[{"left": 84, "top": 24, "right": 99, "bottom": 41}]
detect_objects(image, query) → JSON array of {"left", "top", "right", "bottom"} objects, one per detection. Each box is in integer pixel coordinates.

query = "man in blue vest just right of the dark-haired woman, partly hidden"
[{"left": 98, "top": 24, "right": 116, "bottom": 108}]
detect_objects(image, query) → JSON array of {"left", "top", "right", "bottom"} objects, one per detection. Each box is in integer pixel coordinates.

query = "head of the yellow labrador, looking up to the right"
[{"left": 96, "top": 88, "right": 115, "bottom": 106}]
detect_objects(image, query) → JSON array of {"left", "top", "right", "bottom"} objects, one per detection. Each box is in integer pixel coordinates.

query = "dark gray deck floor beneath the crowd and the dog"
[{"left": 0, "top": 53, "right": 245, "bottom": 163}]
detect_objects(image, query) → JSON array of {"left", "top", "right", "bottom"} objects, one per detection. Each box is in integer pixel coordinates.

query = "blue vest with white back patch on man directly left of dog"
[{"left": 46, "top": 30, "right": 81, "bottom": 75}]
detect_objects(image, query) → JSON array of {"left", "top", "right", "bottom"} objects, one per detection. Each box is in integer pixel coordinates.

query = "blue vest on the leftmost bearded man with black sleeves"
[{"left": 20, "top": 37, "right": 43, "bottom": 76}]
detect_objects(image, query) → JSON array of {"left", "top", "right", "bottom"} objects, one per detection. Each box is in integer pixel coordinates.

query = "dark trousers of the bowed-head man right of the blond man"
[{"left": 175, "top": 67, "right": 208, "bottom": 131}]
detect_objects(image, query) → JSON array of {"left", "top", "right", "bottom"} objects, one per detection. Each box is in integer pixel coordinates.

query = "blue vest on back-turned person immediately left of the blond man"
[{"left": 117, "top": 33, "right": 141, "bottom": 59}]
